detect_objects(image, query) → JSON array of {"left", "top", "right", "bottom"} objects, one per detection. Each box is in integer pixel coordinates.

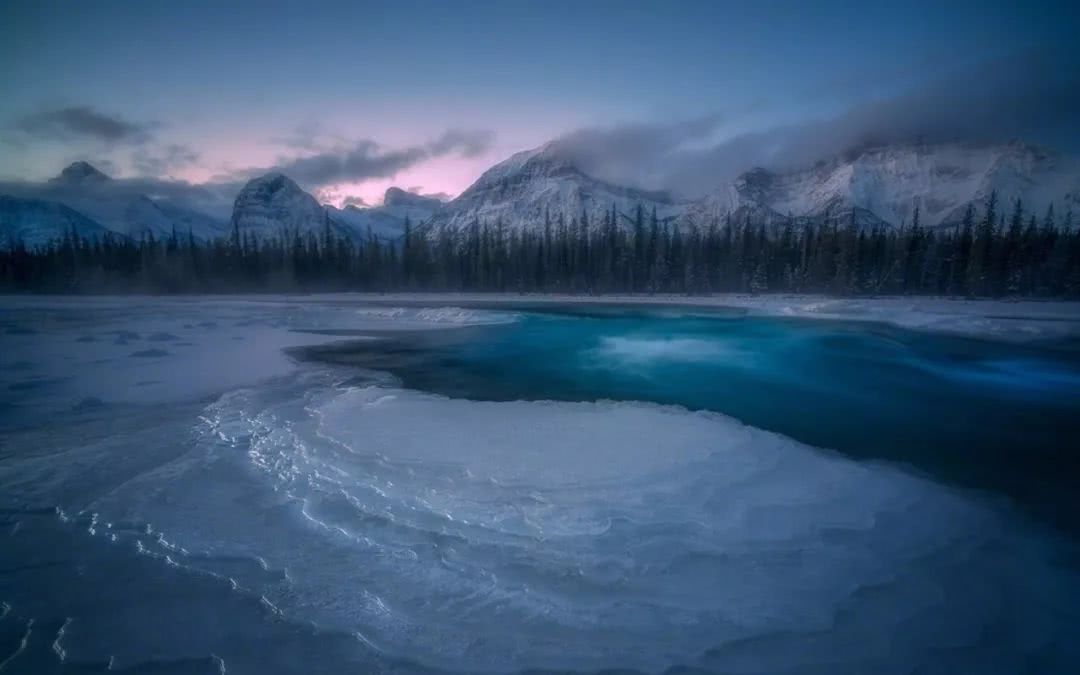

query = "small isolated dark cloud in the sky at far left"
[{"left": 12, "top": 106, "right": 154, "bottom": 144}]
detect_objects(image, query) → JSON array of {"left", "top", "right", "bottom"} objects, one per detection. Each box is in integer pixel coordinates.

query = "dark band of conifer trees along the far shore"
[{"left": 0, "top": 194, "right": 1080, "bottom": 297}]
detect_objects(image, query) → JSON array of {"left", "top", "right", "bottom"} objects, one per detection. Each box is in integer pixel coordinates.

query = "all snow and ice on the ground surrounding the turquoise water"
[{"left": 0, "top": 295, "right": 1080, "bottom": 674}]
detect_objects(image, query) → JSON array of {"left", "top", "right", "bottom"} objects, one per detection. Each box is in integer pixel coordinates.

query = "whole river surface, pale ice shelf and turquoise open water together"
[{"left": 0, "top": 298, "right": 1080, "bottom": 675}]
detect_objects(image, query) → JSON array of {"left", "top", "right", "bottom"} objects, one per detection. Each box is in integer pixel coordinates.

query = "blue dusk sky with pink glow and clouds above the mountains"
[{"left": 0, "top": 0, "right": 1080, "bottom": 205}]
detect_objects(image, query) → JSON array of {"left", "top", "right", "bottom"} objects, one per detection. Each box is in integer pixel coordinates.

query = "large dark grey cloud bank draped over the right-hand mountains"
[{"left": 554, "top": 54, "right": 1080, "bottom": 197}]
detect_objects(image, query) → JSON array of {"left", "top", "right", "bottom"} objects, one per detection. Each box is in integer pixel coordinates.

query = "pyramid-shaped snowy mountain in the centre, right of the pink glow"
[{"left": 429, "top": 144, "right": 687, "bottom": 231}]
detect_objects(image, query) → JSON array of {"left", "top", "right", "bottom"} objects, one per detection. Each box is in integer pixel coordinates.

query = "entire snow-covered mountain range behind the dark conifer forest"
[{"left": 0, "top": 141, "right": 1080, "bottom": 244}]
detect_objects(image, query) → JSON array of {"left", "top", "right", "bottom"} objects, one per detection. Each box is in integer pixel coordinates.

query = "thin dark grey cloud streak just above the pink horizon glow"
[{"left": 235, "top": 130, "right": 494, "bottom": 187}]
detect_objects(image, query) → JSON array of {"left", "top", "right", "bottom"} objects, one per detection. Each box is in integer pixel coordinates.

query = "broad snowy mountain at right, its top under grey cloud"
[{"left": 687, "top": 143, "right": 1080, "bottom": 227}]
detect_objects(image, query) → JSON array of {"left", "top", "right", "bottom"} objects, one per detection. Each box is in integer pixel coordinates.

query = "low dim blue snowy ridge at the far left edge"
[{"left": 0, "top": 195, "right": 108, "bottom": 247}]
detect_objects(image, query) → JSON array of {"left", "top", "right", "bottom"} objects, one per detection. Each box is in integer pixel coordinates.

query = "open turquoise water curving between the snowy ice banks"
[{"left": 300, "top": 308, "right": 1080, "bottom": 529}]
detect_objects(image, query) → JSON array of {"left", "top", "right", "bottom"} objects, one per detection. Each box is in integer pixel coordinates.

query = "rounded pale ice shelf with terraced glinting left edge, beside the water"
[{"left": 194, "top": 386, "right": 1080, "bottom": 673}]
